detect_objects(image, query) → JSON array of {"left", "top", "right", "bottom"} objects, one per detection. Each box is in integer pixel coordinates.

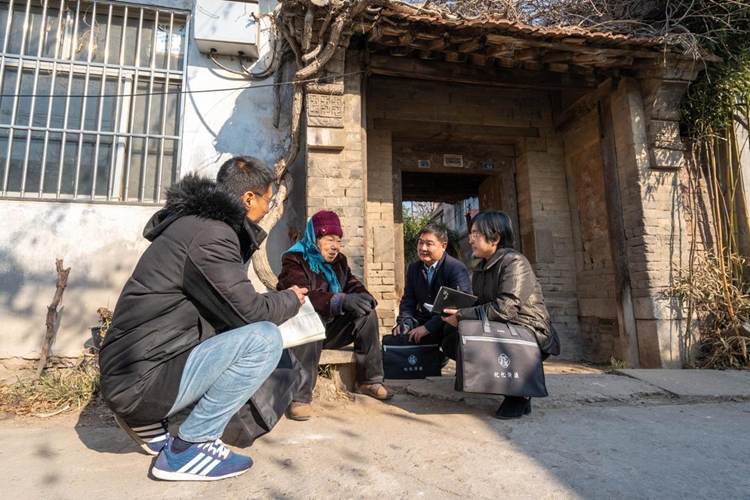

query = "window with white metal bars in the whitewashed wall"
[{"left": 0, "top": 0, "right": 188, "bottom": 203}]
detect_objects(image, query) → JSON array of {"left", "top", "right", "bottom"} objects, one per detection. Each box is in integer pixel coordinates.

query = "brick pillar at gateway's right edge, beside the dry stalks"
[{"left": 611, "top": 78, "right": 688, "bottom": 368}]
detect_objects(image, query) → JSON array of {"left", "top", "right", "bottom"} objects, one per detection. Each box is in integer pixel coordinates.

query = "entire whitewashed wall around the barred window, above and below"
[{"left": 0, "top": 0, "right": 304, "bottom": 359}]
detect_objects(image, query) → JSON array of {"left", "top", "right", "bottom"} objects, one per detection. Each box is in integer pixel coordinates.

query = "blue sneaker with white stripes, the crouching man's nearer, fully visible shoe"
[{"left": 151, "top": 437, "right": 253, "bottom": 481}]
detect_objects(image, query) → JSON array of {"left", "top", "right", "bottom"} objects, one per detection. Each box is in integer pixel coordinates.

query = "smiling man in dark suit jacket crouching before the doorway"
[{"left": 394, "top": 224, "right": 471, "bottom": 362}]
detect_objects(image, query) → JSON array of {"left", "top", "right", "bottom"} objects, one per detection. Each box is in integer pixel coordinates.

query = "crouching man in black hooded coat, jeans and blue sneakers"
[{"left": 99, "top": 157, "right": 307, "bottom": 481}]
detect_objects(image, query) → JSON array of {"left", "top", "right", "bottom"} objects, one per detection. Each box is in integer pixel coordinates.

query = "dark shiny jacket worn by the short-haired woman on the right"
[{"left": 456, "top": 248, "right": 560, "bottom": 355}]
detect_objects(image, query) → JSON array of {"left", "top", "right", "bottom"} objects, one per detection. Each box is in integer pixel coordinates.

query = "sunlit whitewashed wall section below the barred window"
[{"left": 0, "top": 201, "right": 153, "bottom": 358}]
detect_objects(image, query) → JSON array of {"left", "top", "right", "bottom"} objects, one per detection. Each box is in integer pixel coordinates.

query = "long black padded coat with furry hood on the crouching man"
[{"left": 99, "top": 175, "right": 300, "bottom": 424}]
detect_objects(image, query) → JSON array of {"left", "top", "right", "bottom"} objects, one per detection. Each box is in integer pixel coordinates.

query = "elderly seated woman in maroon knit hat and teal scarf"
[{"left": 277, "top": 210, "right": 392, "bottom": 420}]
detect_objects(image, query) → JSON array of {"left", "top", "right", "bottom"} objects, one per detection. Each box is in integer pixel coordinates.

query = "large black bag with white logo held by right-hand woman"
[{"left": 456, "top": 307, "right": 547, "bottom": 398}]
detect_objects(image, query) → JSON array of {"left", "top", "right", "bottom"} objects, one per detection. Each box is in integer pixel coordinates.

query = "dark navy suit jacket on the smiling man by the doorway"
[{"left": 396, "top": 253, "right": 471, "bottom": 334}]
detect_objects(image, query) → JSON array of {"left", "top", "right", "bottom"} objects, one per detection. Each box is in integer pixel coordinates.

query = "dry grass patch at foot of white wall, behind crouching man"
[{"left": 0, "top": 357, "right": 99, "bottom": 416}]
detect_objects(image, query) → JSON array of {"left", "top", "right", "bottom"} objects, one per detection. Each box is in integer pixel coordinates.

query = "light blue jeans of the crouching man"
[{"left": 168, "top": 321, "right": 282, "bottom": 443}]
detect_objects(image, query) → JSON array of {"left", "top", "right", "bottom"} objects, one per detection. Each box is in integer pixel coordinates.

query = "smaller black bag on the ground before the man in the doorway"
[{"left": 383, "top": 335, "right": 443, "bottom": 380}]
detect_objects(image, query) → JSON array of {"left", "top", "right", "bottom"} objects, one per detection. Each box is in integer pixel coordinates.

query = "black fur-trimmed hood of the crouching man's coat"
[{"left": 143, "top": 174, "right": 266, "bottom": 254}]
